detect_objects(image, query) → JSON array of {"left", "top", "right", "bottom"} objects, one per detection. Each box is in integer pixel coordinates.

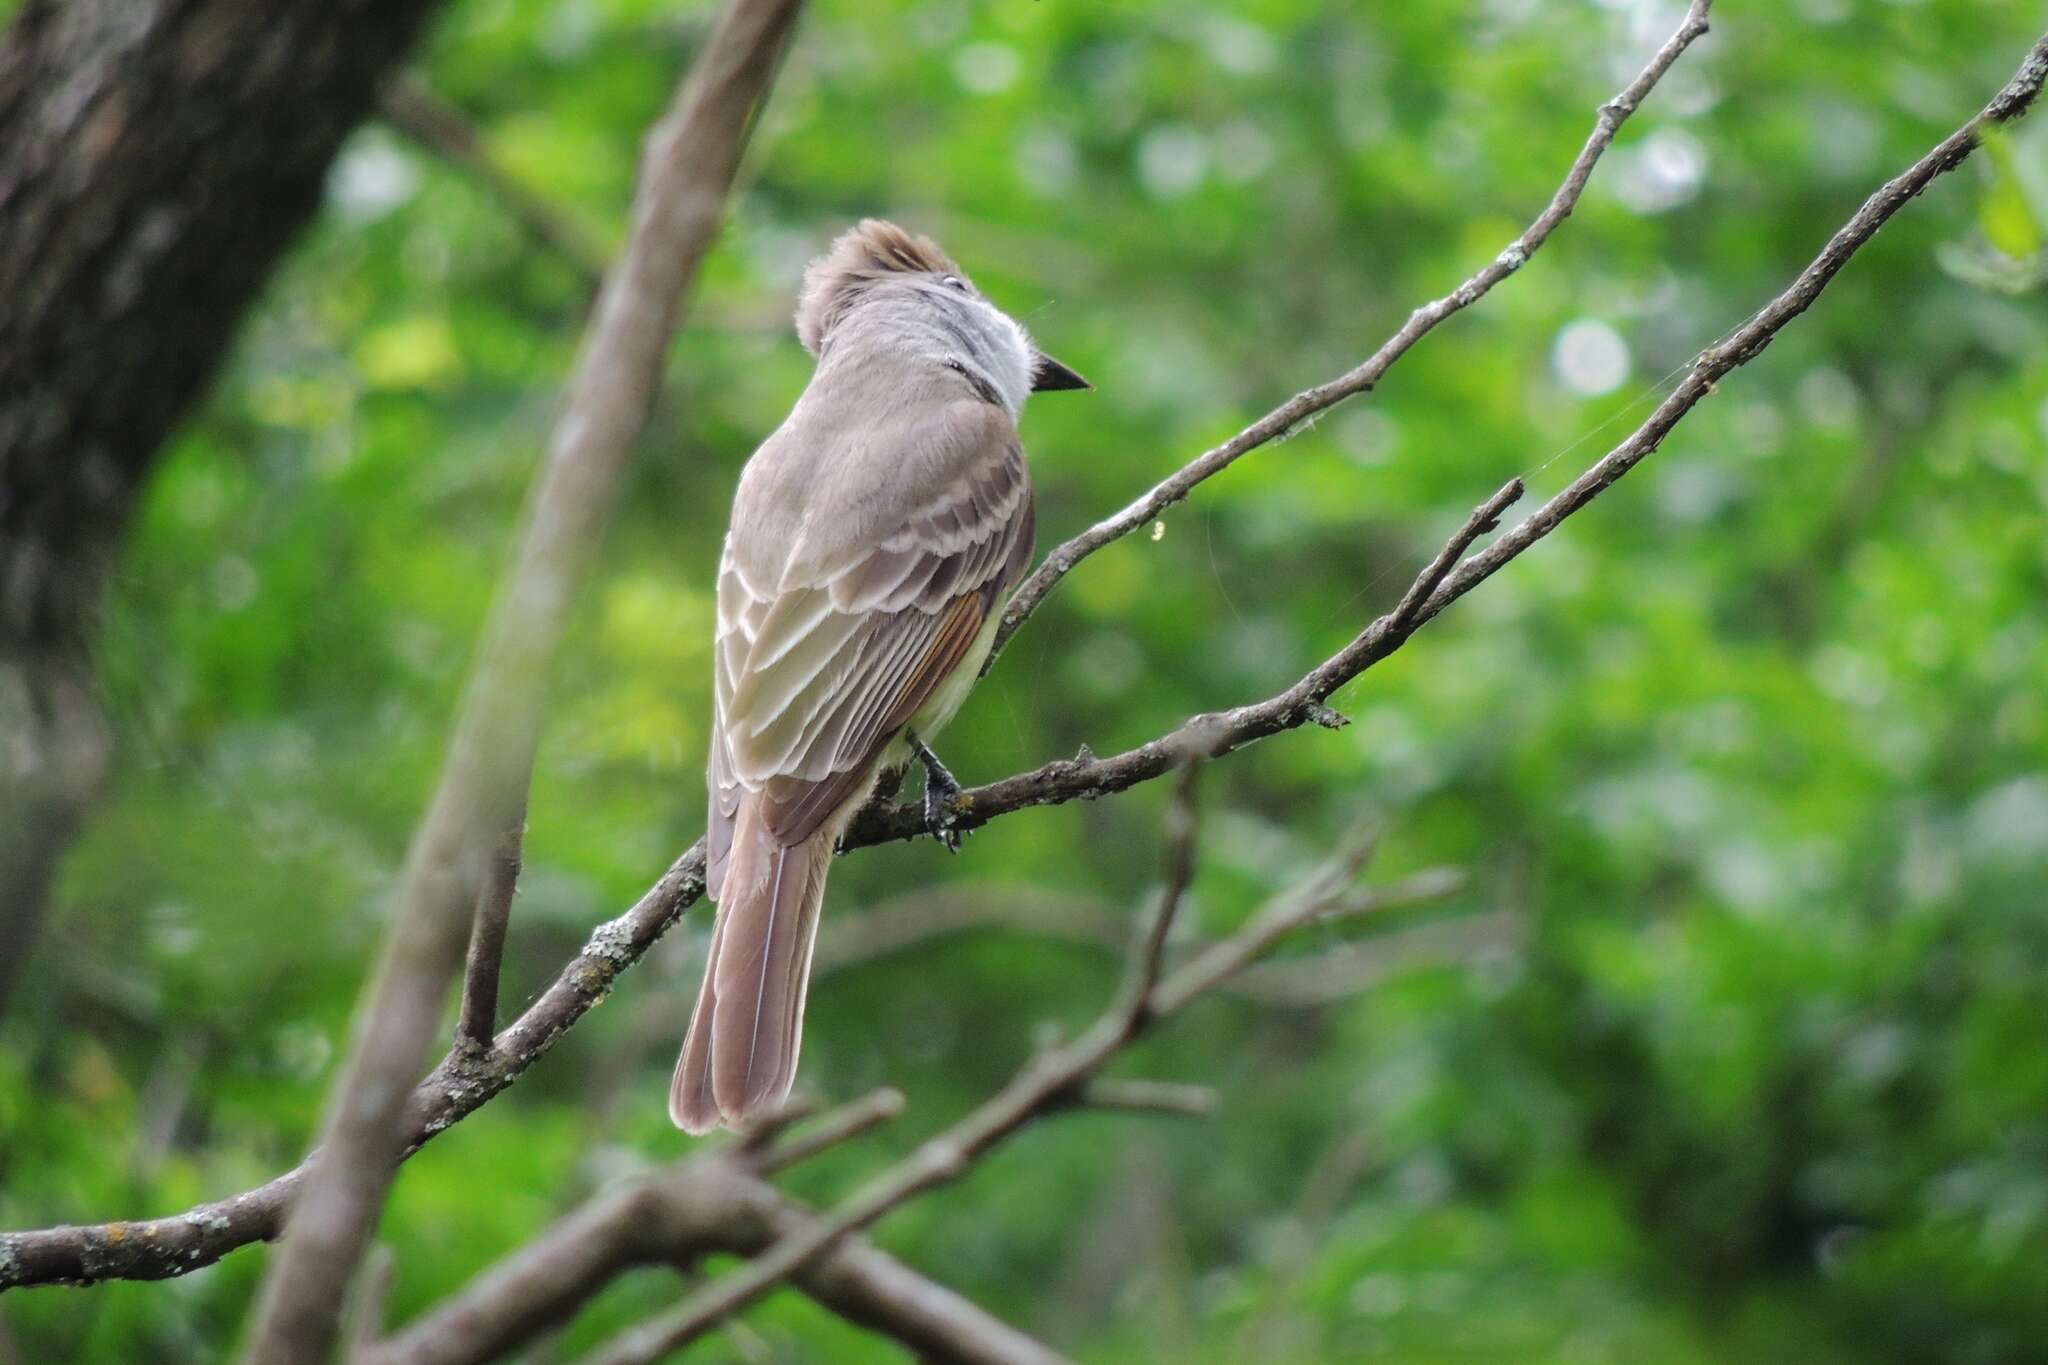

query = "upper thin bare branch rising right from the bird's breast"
[{"left": 983, "top": 0, "right": 1714, "bottom": 671}]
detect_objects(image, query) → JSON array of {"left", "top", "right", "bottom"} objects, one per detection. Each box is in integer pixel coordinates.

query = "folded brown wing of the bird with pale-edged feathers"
[{"left": 711, "top": 401, "right": 1034, "bottom": 847}]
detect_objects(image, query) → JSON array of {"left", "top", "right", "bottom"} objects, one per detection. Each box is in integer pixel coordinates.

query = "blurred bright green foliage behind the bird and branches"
[{"left": 0, "top": 0, "right": 2048, "bottom": 1365}]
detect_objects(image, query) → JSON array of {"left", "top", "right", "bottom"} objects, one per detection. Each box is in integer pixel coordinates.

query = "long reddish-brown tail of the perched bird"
[{"left": 668, "top": 794, "right": 840, "bottom": 1134}]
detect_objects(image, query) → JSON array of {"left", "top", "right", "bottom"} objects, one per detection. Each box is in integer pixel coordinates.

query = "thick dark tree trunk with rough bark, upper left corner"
[{"left": 0, "top": 0, "right": 436, "bottom": 1007}]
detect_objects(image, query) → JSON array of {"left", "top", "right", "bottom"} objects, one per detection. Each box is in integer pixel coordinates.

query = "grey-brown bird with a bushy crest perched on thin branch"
[{"left": 668, "top": 219, "right": 1087, "bottom": 1134}]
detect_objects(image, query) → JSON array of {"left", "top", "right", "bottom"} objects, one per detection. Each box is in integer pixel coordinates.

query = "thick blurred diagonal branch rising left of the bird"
[{"left": 244, "top": 0, "right": 801, "bottom": 1365}]
